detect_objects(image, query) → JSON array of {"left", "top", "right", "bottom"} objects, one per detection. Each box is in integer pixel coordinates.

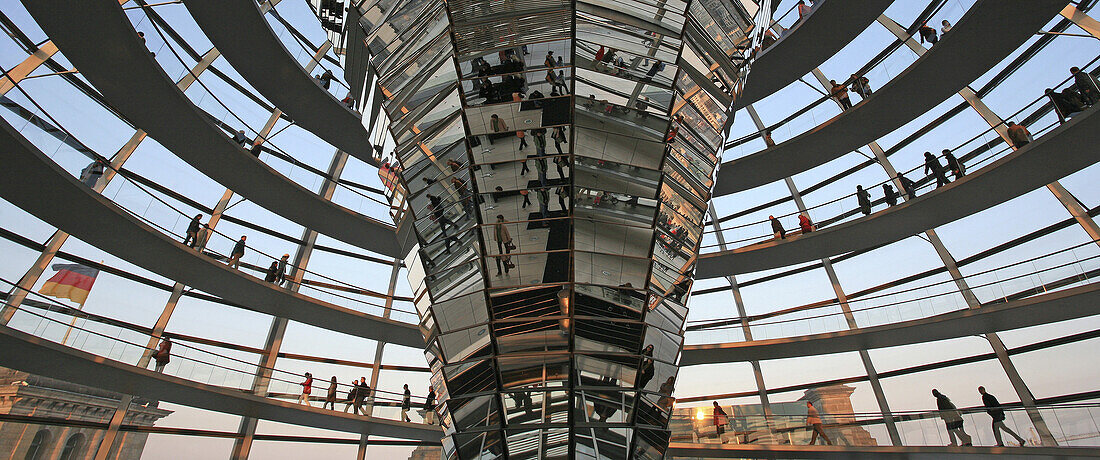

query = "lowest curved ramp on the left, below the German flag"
[{"left": 0, "top": 326, "right": 442, "bottom": 441}]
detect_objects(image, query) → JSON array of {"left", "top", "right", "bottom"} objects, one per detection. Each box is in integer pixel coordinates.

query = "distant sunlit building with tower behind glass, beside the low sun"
[{"left": 669, "top": 385, "right": 879, "bottom": 446}]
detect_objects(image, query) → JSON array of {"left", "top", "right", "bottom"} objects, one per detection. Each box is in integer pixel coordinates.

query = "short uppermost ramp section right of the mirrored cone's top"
[{"left": 734, "top": 0, "right": 893, "bottom": 110}]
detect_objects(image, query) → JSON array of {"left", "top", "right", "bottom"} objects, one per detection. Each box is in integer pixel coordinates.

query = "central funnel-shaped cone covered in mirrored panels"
[{"left": 360, "top": 0, "right": 771, "bottom": 459}]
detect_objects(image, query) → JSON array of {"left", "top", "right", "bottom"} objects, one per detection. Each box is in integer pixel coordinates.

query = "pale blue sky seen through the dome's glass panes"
[{"left": 0, "top": 0, "right": 1100, "bottom": 458}]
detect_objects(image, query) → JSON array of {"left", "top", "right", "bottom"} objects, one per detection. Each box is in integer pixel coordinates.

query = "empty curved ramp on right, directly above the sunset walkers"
[{"left": 680, "top": 284, "right": 1100, "bottom": 365}]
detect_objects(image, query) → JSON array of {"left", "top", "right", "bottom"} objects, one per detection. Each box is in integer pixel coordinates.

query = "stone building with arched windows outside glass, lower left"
[{"left": 0, "top": 368, "right": 172, "bottom": 460}]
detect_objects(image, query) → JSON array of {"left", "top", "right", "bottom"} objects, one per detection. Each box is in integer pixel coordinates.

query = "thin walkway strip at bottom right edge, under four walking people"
[{"left": 666, "top": 442, "right": 1100, "bottom": 460}]
